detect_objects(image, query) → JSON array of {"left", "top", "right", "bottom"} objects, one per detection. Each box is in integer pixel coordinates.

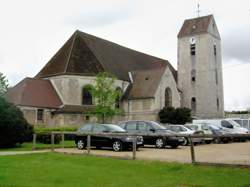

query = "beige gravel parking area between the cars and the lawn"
[{"left": 55, "top": 142, "right": 250, "bottom": 165}]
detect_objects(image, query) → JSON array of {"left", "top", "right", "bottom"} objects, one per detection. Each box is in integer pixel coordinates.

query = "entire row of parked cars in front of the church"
[{"left": 75, "top": 120, "right": 248, "bottom": 151}]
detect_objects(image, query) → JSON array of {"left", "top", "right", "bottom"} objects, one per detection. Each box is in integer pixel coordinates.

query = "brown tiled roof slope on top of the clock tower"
[{"left": 178, "top": 15, "right": 213, "bottom": 38}]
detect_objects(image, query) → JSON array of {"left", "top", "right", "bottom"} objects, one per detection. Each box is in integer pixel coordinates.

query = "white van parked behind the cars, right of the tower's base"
[{"left": 193, "top": 119, "right": 249, "bottom": 134}]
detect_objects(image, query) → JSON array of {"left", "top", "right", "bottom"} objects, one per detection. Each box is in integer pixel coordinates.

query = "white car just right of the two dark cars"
[{"left": 166, "top": 125, "right": 204, "bottom": 145}]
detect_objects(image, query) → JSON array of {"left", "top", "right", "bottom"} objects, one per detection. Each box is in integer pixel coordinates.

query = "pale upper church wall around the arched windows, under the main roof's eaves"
[{"left": 49, "top": 75, "right": 129, "bottom": 105}]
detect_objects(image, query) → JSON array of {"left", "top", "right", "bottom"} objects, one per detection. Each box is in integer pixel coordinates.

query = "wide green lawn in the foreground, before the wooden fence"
[{"left": 0, "top": 153, "right": 250, "bottom": 187}]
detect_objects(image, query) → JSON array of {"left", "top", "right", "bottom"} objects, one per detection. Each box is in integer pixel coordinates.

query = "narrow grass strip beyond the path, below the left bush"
[{"left": 0, "top": 140, "right": 75, "bottom": 152}]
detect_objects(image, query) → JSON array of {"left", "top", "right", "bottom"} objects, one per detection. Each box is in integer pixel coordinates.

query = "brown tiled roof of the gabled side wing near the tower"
[{"left": 124, "top": 68, "right": 166, "bottom": 99}]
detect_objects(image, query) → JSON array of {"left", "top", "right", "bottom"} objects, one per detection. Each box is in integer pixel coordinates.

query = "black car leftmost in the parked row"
[{"left": 75, "top": 124, "right": 143, "bottom": 151}]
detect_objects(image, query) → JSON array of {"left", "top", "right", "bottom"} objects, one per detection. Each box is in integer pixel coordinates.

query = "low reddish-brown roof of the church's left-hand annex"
[{"left": 6, "top": 78, "right": 62, "bottom": 108}]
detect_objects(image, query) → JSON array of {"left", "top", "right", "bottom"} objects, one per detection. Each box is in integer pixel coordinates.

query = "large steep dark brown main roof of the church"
[{"left": 36, "top": 31, "right": 176, "bottom": 81}]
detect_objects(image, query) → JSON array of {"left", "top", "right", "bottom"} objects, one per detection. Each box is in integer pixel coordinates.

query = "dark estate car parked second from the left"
[{"left": 118, "top": 120, "right": 184, "bottom": 148}]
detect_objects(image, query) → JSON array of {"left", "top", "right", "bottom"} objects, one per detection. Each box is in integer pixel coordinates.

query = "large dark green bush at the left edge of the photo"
[{"left": 0, "top": 97, "right": 33, "bottom": 147}]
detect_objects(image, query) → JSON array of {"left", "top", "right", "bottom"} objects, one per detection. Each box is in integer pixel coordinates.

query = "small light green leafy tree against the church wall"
[{"left": 91, "top": 72, "right": 121, "bottom": 123}]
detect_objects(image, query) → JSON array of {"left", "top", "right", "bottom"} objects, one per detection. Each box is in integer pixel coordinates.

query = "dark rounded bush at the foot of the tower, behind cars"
[{"left": 159, "top": 107, "right": 192, "bottom": 124}]
